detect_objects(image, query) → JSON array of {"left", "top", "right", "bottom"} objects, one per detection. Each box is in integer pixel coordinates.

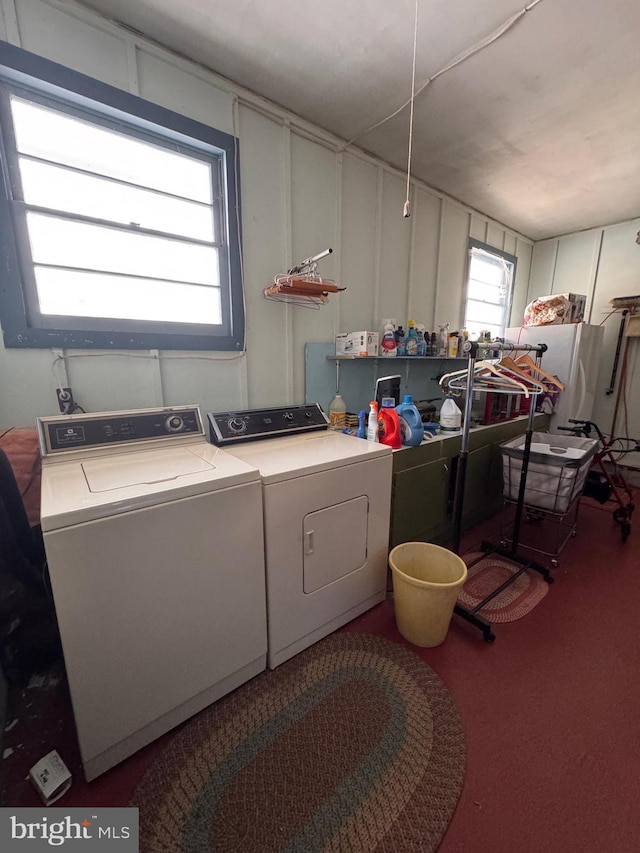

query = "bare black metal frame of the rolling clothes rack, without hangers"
[{"left": 453, "top": 341, "right": 553, "bottom": 642}]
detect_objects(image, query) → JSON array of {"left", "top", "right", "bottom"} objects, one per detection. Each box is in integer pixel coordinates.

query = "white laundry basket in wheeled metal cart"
[{"left": 501, "top": 432, "right": 598, "bottom": 515}]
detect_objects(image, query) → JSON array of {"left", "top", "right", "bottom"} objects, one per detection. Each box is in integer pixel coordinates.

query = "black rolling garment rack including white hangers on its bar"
[{"left": 441, "top": 341, "right": 553, "bottom": 643}]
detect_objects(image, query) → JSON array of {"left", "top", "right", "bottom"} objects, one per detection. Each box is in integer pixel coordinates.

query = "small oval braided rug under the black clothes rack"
[{"left": 458, "top": 551, "right": 549, "bottom": 623}]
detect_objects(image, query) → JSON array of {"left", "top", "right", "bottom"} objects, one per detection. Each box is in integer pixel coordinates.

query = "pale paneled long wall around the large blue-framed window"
[{"left": 0, "top": 0, "right": 528, "bottom": 430}]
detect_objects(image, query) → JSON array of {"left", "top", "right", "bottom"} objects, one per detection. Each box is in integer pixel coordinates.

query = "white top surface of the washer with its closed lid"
[{"left": 41, "top": 441, "right": 260, "bottom": 532}]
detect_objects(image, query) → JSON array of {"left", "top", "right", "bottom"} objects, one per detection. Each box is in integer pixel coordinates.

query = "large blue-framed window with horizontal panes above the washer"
[{"left": 0, "top": 45, "right": 244, "bottom": 350}]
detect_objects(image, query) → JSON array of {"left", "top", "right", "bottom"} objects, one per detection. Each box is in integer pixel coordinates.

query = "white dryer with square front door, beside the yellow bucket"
[{"left": 208, "top": 404, "right": 392, "bottom": 669}]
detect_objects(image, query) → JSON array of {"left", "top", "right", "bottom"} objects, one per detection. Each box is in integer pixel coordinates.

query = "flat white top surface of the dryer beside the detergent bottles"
[{"left": 225, "top": 431, "right": 391, "bottom": 485}]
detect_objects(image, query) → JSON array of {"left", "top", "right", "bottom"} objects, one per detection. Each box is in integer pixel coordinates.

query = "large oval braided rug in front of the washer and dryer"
[{"left": 130, "top": 633, "right": 466, "bottom": 853}]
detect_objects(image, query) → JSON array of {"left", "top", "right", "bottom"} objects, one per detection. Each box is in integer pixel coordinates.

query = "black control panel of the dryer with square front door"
[{"left": 207, "top": 403, "right": 328, "bottom": 446}]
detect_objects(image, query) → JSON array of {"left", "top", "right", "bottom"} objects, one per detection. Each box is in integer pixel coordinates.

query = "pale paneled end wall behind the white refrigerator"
[{"left": 528, "top": 219, "right": 640, "bottom": 466}]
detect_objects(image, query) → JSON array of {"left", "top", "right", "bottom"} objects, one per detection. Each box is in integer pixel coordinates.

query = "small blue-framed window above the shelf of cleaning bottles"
[{"left": 464, "top": 240, "right": 517, "bottom": 339}]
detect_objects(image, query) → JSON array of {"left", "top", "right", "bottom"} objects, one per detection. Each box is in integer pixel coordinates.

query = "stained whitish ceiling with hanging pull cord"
[{"left": 83, "top": 0, "right": 640, "bottom": 240}]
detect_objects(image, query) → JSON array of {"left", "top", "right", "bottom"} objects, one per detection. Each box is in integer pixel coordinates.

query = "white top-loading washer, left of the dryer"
[{"left": 38, "top": 406, "right": 267, "bottom": 780}]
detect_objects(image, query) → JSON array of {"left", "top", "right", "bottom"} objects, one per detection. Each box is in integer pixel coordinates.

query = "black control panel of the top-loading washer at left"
[{"left": 37, "top": 406, "right": 204, "bottom": 456}]
